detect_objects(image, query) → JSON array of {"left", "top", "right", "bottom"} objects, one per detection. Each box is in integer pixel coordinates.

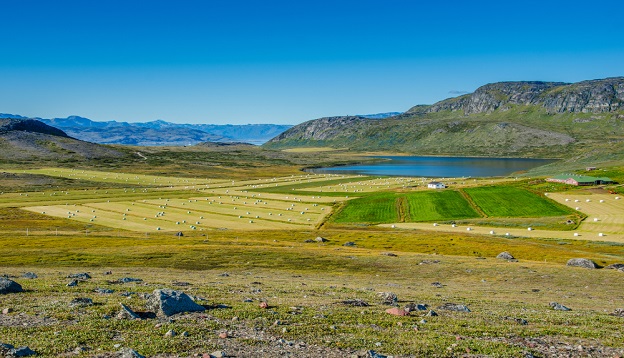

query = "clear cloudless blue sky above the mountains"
[{"left": 0, "top": 0, "right": 624, "bottom": 124}]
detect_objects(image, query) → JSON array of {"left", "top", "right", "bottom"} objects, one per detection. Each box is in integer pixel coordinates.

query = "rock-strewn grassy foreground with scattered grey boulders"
[{"left": 0, "top": 252, "right": 624, "bottom": 358}]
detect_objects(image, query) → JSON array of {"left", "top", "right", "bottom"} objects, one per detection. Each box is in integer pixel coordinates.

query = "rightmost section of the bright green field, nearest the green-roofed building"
[{"left": 465, "top": 186, "right": 573, "bottom": 217}]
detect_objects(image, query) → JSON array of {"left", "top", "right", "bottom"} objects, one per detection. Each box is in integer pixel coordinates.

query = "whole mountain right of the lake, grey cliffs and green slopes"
[{"left": 265, "top": 77, "right": 624, "bottom": 157}]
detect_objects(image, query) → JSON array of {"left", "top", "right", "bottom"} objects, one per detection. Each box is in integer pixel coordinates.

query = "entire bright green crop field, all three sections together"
[{"left": 332, "top": 186, "right": 576, "bottom": 230}]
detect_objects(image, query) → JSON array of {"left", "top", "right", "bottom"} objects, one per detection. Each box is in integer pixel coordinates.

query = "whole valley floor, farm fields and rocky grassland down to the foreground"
[{"left": 0, "top": 148, "right": 624, "bottom": 357}]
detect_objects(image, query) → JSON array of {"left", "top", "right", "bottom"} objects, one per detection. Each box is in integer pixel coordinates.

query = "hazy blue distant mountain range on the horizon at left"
[{"left": 0, "top": 113, "right": 292, "bottom": 146}]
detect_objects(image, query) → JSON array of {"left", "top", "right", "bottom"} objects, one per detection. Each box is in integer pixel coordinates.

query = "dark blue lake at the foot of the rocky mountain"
[{"left": 306, "top": 156, "right": 556, "bottom": 178}]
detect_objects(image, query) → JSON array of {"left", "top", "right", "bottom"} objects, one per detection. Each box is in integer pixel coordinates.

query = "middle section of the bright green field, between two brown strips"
[{"left": 406, "top": 190, "right": 480, "bottom": 222}]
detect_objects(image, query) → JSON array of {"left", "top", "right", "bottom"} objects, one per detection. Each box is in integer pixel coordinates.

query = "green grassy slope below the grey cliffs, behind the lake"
[{"left": 265, "top": 105, "right": 624, "bottom": 158}]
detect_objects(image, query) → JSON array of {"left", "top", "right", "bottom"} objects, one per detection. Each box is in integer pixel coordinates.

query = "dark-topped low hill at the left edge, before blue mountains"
[{"left": 0, "top": 115, "right": 126, "bottom": 163}]
